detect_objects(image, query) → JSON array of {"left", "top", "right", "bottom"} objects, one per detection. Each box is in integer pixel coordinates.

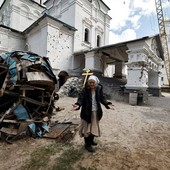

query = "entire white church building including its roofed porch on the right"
[{"left": 0, "top": 0, "right": 167, "bottom": 95}]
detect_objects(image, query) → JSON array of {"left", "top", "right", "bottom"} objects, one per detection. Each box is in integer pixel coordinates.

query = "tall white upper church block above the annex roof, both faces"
[{"left": 46, "top": 0, "right": 111, "bottom": 52}]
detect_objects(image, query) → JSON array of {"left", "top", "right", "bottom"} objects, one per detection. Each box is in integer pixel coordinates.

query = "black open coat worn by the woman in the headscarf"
[{"left": 75, "top": 85, "right": 112, "bottom": 123}]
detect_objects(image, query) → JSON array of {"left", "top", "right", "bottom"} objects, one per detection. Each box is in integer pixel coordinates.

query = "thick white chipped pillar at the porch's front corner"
[{"left": 126, "top": 43, "right": 148, "bottom": 89}]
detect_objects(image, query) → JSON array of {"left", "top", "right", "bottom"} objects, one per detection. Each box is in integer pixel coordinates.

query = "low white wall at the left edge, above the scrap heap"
[{"left": 0, "top": 27, "right": 25, "bottom": 51}]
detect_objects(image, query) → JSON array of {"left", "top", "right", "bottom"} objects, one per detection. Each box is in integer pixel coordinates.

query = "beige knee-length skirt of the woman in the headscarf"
[{"left": 79, "top": 112, "right": 100, "bottom": 137}]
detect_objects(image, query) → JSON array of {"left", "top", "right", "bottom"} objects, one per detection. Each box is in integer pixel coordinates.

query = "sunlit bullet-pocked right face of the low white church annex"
[{"left": 47, "top": 26, "right": 73, "bottom": 70}]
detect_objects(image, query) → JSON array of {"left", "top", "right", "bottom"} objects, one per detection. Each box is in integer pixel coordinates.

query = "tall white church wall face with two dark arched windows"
[{"left": 74, "top": 0, "right": 110, "bottom": 51}]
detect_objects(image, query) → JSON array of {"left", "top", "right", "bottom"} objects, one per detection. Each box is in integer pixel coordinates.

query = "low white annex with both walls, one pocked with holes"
[{"left": 26, "top": 17, "right": 74, "bottom": 71}]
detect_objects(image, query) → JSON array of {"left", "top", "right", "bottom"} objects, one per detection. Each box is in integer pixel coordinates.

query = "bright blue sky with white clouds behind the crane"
[{"left": 0, "top": 0, "right": 170, "bottom": 44}]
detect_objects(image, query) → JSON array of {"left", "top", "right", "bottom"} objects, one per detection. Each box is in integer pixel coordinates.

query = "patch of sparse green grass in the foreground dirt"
[{"left": 21, "top": 143, "right": 85, "bottom": 170}]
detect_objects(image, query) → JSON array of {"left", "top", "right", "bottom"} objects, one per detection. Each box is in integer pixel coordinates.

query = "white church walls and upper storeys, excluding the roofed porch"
[{"left": 0, "top": 0, "right": 111, "bottom": 72}]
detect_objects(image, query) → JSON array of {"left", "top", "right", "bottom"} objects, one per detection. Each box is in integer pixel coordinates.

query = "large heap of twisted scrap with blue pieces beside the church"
[{"left": 0, "top": 51, "right": 58, "bottom": 142}]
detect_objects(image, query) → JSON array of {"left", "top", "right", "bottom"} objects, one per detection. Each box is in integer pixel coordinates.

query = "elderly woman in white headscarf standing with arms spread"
[{"left": 73, "top": 75, "right": 113, "bottom": 152}]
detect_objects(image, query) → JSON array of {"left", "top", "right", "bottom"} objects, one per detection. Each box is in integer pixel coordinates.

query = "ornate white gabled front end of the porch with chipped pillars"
[{"left": 126, "top": 37, "right": 162, "bottom": 96}]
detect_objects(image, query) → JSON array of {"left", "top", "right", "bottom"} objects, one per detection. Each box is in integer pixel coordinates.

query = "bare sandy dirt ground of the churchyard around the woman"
[{"left": 0, "top": 93, "right": 170, "bottom": 170}]
